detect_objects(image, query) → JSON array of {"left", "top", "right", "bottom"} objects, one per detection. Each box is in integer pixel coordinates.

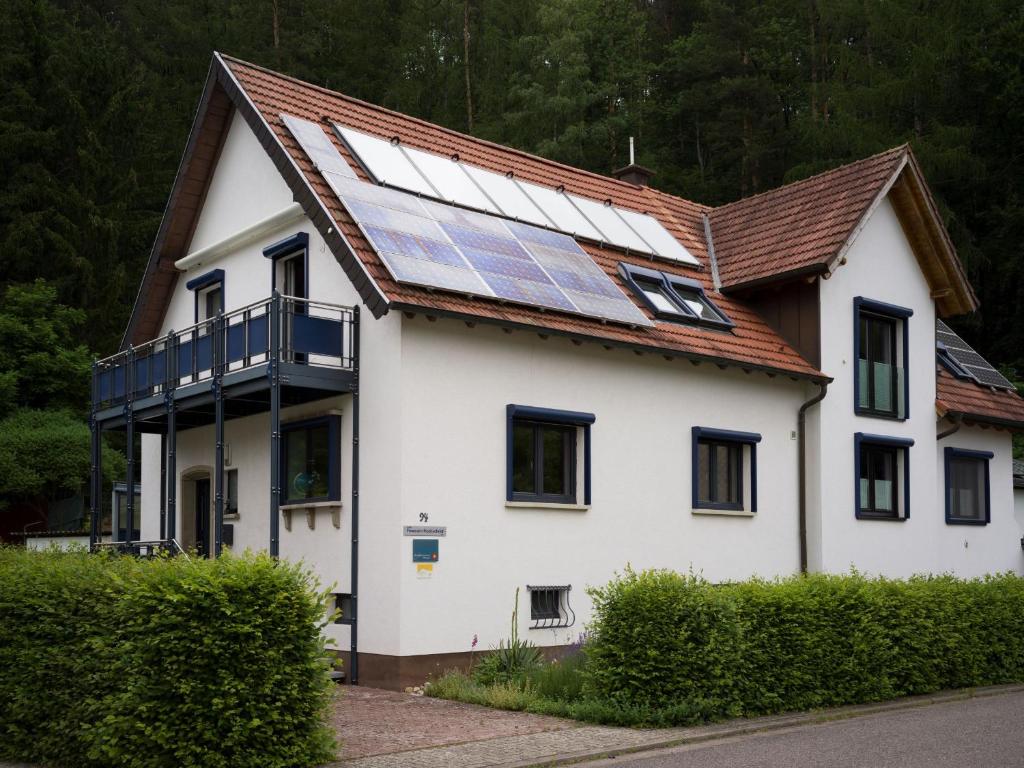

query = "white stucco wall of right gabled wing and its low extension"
[{"left": 810, "top": 200, "right": 1021, "bottom": 577}]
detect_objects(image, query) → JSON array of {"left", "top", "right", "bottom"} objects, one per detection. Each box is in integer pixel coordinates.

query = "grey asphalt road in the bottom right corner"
[{"left": 585, "top": 692, "right": 1024, "bottom": 768}]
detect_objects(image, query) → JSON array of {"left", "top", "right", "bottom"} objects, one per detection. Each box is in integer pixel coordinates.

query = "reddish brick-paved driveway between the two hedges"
[{"left": 332, "top": 685, "right": 578, "bottom": 760}]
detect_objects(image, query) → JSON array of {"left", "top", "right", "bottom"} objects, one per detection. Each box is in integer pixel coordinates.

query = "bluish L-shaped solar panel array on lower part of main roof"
[{"left": 282, "top": 116, "right": 651, "bottom": 326}]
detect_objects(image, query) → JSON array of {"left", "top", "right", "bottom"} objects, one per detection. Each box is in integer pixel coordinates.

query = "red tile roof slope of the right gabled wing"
[{"left": 711, "top": 144, "right": 908, "bottom": 288}]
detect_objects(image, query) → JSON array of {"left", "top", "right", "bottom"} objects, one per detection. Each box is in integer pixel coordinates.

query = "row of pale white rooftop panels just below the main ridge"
[{"left": 334, "top": 124, "right": 698, "bottom": 264}]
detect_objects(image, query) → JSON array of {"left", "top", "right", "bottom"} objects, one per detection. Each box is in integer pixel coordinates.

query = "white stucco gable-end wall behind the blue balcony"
[{"left": 135, "top": 116, "right": 401, "bottom": 653}]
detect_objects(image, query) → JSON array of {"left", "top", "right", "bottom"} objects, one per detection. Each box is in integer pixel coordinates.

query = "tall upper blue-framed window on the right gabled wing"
[{"left": 853, "top": 296, "right": 913, "bottom": 419}]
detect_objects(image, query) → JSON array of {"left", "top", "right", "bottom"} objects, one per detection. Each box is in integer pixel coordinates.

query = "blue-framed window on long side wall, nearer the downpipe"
[{"left": 691, "top": 427, "right": 761, "bottom": 512}]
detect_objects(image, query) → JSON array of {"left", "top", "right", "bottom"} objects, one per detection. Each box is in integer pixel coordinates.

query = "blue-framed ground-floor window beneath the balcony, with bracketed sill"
[{"left": 281, "top": 416, "right": 341, "bottom": 504}]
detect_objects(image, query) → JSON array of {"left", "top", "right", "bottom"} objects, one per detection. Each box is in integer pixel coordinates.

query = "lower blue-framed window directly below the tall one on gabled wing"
[{"left": 854, "top": 432, "right": 913, "bottom": 520}]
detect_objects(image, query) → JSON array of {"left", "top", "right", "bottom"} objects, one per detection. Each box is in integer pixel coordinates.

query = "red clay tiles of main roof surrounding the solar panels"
[{"left": 223, "top": 57, "right": 827, "bottom": 380}]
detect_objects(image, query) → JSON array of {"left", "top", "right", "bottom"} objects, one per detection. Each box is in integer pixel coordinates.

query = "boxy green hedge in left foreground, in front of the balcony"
[{"left": 0, "top": 548, "right": 334, "bottom": 768}]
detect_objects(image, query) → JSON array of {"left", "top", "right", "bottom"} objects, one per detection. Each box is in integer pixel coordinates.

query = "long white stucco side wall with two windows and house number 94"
[{"left": 393, "top": 316, "right": 808, "bottom": 654}]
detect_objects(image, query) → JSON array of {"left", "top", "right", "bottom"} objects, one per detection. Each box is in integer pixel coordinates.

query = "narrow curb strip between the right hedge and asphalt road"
[{"left": 505, "top": 684, "right": 1024, "bottom": 768}]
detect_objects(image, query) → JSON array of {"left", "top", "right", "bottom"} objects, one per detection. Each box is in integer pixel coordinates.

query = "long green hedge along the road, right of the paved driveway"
[{"left": 587, "top": 570, "right": 1024, "bottom": 719}]
